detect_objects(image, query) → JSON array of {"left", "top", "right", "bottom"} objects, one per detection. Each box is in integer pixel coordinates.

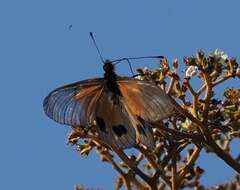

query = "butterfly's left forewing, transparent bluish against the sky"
[{"left": 43, "top": 78, "right": 103, "bottom": 126}]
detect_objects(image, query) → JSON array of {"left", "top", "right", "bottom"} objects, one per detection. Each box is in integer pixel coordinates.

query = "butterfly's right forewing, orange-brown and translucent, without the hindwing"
[{"left": 118, "top": 77, "right": 174, "bottom": 122}]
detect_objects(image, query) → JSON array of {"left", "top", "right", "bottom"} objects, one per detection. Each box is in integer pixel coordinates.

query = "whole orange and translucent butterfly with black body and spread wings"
[{"left": 43, "top": 60, "right": 174, "bottom": 149}]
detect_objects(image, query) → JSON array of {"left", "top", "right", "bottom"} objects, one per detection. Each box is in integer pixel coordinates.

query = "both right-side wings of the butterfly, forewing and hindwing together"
[{"left": 118, "top": 77, "right": 174, "bottom": 149}]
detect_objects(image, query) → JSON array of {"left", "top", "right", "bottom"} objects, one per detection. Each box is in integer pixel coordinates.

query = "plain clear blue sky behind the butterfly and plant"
[{"left": 0, "top": 0, "right": 240, "bottom": 190}]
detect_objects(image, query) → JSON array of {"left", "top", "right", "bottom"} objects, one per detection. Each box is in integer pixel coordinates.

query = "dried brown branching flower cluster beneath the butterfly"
[{"left": 69, "top": 50, "right": 240, "bottom": 190}]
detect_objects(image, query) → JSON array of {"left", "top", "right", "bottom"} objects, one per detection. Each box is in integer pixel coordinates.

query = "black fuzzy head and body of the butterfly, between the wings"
[{"left": 103, "top": 60, "right": 122, "bottom": 100}]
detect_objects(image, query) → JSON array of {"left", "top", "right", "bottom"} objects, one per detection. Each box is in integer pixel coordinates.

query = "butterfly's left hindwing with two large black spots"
[{"left": 96, "top": 89, "right": 136, "bottom": 148}]
